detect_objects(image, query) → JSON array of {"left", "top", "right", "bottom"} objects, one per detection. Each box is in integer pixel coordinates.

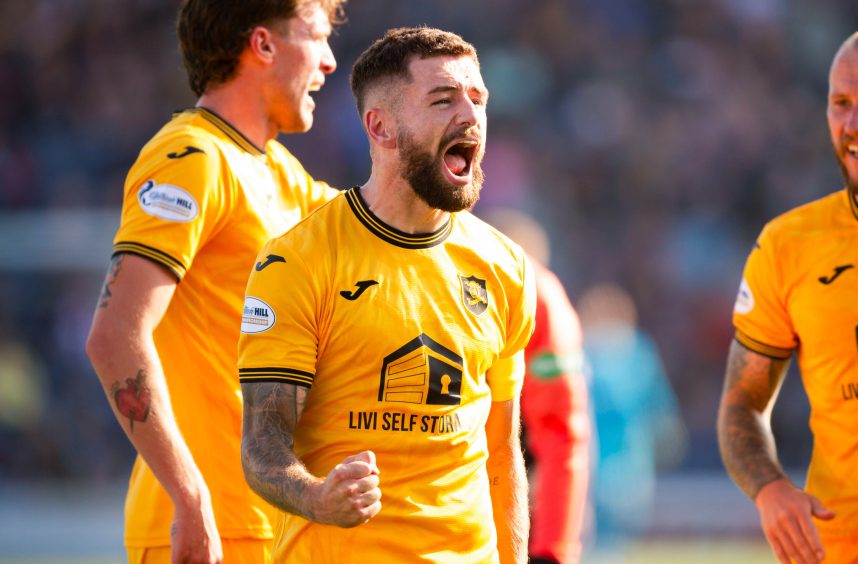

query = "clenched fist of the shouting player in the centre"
[{"left": 312, "top": 450, "right": 381, "bottom": 528}]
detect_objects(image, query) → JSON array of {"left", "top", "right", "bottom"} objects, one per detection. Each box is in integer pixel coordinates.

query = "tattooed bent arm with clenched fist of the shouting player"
[{"left": 241, "top": 382, "right": 381, "bottom": 527}]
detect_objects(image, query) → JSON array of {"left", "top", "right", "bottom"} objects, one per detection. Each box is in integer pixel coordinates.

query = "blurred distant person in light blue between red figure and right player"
[{"left": 578, "top": 284, "right": 686, "bottom": 550}]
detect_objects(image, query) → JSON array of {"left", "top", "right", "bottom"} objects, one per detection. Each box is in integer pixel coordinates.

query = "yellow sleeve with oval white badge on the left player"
[{"left": 113, "top": 135, "right": 224, "bottom": 280}]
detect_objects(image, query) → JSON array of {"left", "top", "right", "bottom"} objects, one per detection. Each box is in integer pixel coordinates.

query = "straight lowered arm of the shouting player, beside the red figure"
[{"left": 486, "top": 398, "right": 530, "bottom": 564}]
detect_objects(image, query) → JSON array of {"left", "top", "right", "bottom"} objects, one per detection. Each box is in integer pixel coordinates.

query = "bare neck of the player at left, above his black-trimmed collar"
[{"left": 197, "top": 80, "right": 277, "bottom": 151}]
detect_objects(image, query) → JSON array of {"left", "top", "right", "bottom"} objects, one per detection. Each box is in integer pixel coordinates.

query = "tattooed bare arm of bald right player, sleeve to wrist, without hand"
[{"left": 718, "top": 341, "right": 789, "bottom": 498}]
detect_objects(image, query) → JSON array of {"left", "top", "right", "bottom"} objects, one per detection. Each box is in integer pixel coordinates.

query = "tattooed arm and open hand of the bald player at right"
[{"left": 718, "top": 341, "right": 834, "bottom": 563}]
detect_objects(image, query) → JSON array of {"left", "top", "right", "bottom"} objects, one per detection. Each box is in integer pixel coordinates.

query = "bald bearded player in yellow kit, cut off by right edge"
[{"left": 718, "top": 33, "right": 858, "bottom": 563}]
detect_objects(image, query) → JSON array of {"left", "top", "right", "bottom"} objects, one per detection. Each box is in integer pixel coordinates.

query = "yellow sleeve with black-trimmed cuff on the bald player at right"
[{"left": 733, "top": 226, "right": 798, "bottom": 358}]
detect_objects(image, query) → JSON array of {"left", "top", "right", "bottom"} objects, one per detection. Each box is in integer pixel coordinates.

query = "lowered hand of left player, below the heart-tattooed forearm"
[{"left": 170, "top": 491, "right": 223, "bottom": 564}]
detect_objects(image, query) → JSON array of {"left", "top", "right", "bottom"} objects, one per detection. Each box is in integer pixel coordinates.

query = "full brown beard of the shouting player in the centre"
[{"left": 397, "top": 128, "right": 483, "bottom": 213}]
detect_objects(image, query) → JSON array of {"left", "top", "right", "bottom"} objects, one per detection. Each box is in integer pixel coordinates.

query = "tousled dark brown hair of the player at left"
[{"left": 176, "top": 0, "right": 345, "bottom": 96}]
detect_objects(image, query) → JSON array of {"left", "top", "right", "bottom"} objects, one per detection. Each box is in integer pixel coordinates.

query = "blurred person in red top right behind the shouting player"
[{"left": 481, "top": 209, "right": 590, "bottom": 564}]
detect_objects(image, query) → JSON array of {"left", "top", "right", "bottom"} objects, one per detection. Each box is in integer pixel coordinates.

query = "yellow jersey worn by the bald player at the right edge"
[{"left": 733, "top": 190, "right": 858, "bottom": 535}]
